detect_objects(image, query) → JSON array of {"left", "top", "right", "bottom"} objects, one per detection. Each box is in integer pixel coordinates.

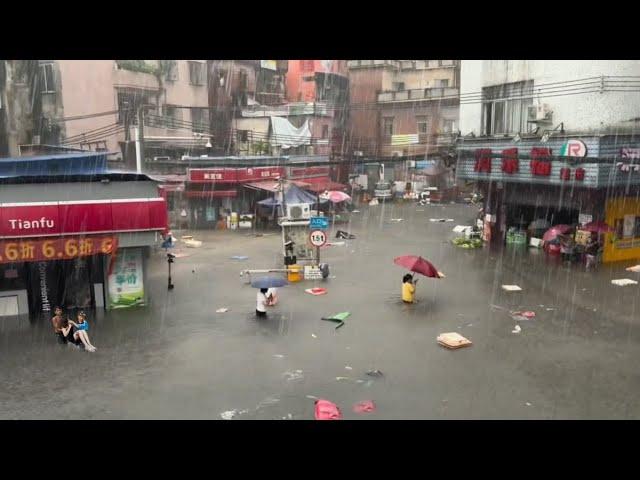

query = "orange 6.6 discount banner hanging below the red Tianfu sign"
[{"left": 0, "top": 237, "right": 118, "bottom": 264}]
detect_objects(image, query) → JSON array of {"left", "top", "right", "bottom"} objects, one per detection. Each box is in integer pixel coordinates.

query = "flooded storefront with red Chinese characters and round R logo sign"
[{"left": 457, "top": 137, "right": 640, "bottom": 262}]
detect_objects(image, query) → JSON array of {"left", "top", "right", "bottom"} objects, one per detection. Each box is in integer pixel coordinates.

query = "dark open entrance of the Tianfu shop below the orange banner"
[{"left": 26, "top": 255, "right": 104, "bottom": 316}]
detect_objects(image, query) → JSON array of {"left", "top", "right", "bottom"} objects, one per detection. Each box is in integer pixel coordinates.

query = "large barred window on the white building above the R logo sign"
[{"left": 482, "top": 80, "right": 533, "bottom": 135}]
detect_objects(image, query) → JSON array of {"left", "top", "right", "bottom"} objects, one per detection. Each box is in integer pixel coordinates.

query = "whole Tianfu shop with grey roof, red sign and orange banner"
[{"left": 0, "top": 173, "right": 167, "bottom": 317}]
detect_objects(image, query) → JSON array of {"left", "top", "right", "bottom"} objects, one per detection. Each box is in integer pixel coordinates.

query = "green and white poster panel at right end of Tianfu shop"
[{"left": 108, "top": 248, "right": 144, "bottom": 309}]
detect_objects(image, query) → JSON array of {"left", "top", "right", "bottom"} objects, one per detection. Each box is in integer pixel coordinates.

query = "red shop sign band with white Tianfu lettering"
[{"left": 0, "top": 198, "right": 167, "bottom": 238}]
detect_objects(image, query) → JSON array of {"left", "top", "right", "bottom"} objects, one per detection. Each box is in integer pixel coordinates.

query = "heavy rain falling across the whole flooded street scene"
[{"left": 0, "top": 60, "right": 640, "bottom": 421}]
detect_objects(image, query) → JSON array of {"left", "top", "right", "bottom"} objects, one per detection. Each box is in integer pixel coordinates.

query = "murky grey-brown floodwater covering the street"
[{"left": 0, "top": 204, "right": 640, "bottom": 420}]
